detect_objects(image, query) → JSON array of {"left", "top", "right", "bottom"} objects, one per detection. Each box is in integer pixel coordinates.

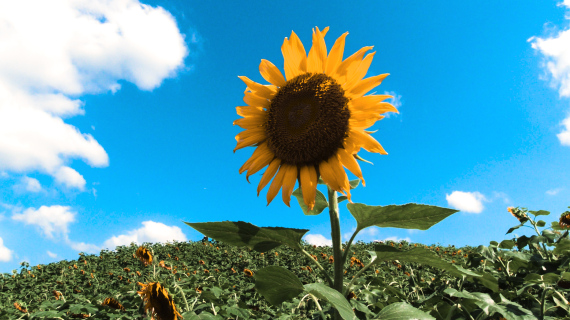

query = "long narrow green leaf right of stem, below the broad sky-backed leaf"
[{"left": 370, "top": 245, "right": 490, "bottom": 278}]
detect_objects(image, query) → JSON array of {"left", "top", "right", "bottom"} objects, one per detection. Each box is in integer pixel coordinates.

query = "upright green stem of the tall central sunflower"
[{"left": 327, "top": 186, "right": 344, "bottom": 294}]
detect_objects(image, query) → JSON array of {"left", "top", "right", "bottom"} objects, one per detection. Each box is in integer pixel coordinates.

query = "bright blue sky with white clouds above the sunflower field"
[{"left": 0, "top": 0, "right": 570, "bottom": 272}]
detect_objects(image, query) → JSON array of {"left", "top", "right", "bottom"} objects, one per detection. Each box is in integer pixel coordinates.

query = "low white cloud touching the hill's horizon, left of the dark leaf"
[{"left": 103, "top": 221, "right": 187, "bottom": 250}]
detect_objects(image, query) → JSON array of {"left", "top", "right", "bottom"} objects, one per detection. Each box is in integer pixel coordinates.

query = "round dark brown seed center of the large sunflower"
[{"left": 265, "top": 73, "right": 350, "bottom": 165}]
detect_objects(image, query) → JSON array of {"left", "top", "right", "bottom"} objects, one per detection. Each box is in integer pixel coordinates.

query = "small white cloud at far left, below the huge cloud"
[{"left": 12, "top": 205, "right": 75, "bottom": 239}]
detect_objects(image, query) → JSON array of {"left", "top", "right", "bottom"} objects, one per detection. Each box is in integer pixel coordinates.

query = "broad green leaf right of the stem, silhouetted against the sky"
[{"left": 346, "top": 203, "right": 459, "bottom": 231}]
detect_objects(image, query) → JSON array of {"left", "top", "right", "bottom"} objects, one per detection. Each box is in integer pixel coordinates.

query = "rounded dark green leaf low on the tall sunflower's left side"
[{"left": 253, "top": 266, "right": 304, "bottom": 305}]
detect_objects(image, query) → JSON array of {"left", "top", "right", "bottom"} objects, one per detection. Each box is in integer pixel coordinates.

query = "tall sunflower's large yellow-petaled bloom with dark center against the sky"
[{"left": 234, "top": 27, "right": 398, "bottom": 209}]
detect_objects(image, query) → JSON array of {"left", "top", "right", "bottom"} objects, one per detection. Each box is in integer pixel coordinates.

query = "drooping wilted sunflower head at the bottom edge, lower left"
[{"left": 137, "top": 282, "right": 182, "bottom": 320}]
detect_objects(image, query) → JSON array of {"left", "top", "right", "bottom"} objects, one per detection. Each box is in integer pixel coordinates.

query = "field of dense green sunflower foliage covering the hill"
[{"left": 0, "top": 206, "right": 570, "bottom": 320}]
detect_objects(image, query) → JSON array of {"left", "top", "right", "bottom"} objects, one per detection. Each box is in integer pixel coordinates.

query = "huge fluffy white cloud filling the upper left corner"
[{"left": 0, "top": 0, "right": 188, "bottom": 189}]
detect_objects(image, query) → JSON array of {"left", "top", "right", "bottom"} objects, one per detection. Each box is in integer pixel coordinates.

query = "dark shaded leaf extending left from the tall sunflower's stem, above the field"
[{"left": 184, "top": 221, "right": 309, "bottom": 252}]
